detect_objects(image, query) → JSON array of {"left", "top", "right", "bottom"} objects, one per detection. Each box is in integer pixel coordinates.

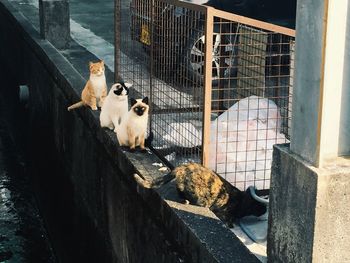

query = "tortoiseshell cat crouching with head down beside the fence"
[{"left": 134, "top": 163, "right": 266, "bottom": 227}]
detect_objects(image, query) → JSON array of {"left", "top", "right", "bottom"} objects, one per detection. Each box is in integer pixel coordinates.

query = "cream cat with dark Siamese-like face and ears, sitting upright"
[{"left": 114, "top": 97, "right": 149, "bottom": 150}]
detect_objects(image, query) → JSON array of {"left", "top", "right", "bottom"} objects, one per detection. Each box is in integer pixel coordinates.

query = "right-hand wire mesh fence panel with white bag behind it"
[{"left": 207, "top": 17, "right": 294, "bottom": 189}]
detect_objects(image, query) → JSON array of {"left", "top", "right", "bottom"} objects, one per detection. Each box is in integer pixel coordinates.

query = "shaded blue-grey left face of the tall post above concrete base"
[{"left": 291, "top": 1, "right": 324, "bottom": 165}]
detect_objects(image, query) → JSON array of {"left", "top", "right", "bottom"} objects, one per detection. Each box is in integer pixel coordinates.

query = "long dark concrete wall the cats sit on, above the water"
[{"left": 0, "top": 0, "right": 259, "bottom": 263}]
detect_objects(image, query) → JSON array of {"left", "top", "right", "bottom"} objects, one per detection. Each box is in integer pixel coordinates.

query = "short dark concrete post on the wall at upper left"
[{"left": 39, "top": 0, "right": 70, "bottom": 49}]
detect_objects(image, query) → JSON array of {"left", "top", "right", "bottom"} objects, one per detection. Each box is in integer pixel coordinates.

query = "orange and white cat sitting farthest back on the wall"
[{"left": 68, "top": 60, "right": 107, "bottom": 111}]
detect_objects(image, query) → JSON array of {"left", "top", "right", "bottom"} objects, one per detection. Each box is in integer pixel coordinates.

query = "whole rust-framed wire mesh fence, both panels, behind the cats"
[{"left": 116, "top": 0, "right": 295, "bottom": 189}]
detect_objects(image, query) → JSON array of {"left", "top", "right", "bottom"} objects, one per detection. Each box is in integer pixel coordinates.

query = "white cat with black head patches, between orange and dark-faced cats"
[{"left": 100, "top": 83, "right": 132, "bottom": 130}]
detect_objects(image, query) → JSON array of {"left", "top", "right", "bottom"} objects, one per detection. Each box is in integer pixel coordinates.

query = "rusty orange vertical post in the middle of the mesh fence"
[{"left": 202, "top": 7, "right": 214, "bottom": 166}]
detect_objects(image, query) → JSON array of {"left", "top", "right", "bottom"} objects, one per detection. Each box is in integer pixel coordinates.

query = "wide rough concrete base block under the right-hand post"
[{"left": 267, "top": 145, "right": 350, "bottom": 263}]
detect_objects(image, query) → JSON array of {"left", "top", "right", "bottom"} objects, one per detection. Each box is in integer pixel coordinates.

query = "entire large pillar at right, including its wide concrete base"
[{"left": 267, "top": 0, "right": 350, "bottom": 263}]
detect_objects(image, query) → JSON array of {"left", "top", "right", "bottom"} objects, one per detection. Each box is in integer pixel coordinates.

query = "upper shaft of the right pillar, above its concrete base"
[{"left": 291, "top": 0, "right": 350, "bottom": 166}]
